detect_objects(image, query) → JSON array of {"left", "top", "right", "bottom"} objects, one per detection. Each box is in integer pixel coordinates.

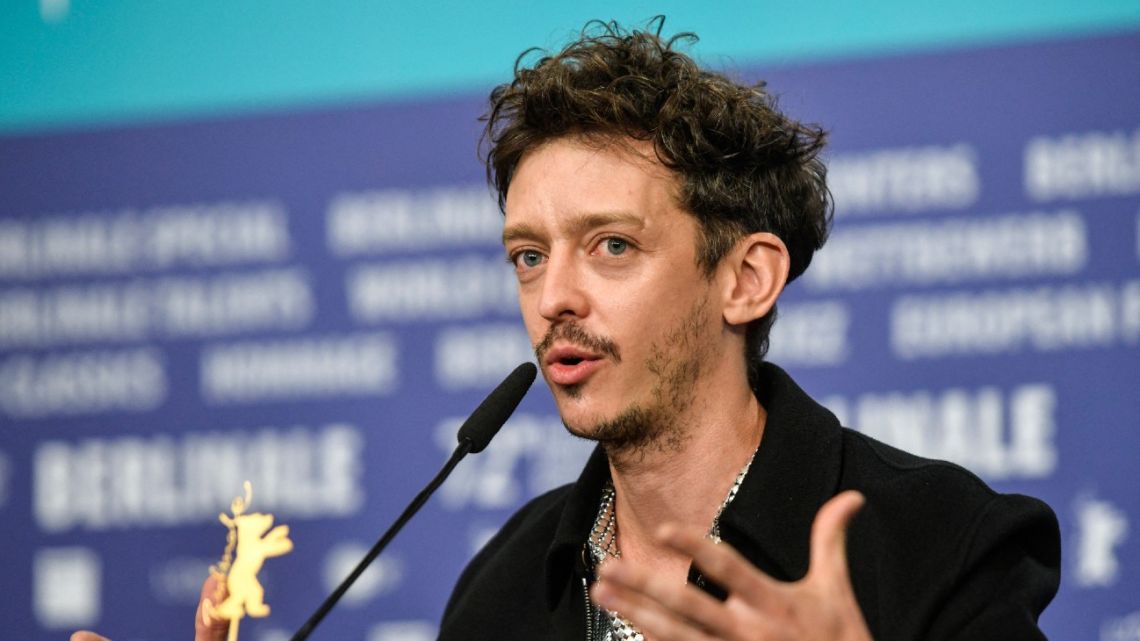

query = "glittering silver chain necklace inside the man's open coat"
[{"left": 586, "top": 452, "right": 756, "bottom": 641}]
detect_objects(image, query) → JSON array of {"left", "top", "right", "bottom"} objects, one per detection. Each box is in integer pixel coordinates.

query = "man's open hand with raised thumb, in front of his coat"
[{"left": 592, "top": 492, "right": 871, "bottom": 641}]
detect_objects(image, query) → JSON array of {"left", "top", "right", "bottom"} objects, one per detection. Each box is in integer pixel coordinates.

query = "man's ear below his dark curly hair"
[{"left": 720, "top": 232, "right": 791, "bottom": 325}]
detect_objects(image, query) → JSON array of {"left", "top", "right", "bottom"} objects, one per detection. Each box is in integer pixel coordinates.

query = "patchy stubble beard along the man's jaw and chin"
[{"left": 562, "top": 298, "right": 711, "bottom": 465}]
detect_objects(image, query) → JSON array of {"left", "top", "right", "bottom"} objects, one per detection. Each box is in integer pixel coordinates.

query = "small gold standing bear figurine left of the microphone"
[{"left": 202, "top": 481, "right": 293, "bottom": 641}]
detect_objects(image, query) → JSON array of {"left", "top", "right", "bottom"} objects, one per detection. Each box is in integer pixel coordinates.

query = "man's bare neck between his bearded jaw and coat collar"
[{"left": 610, "top": 383, "right": 766, "bottom": 568}]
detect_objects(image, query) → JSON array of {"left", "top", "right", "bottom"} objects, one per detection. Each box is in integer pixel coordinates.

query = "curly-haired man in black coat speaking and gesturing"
[{"left": 78, "top": 18, "right": 1059, "bottom": 641}]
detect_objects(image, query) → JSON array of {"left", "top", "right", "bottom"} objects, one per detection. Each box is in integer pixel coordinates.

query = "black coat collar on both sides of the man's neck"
[{"left": 544, "top": 363, "right": 842, "bottom": 609}]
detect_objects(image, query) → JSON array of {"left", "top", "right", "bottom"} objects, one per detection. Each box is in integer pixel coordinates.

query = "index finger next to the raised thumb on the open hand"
[{"left": 658, "top": 524, "right": 777, "bottom": 603}]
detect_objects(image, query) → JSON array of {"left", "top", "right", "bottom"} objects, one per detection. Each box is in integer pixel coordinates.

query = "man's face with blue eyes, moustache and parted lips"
[{"left": 503, "top": 138, "right": 724, "bottom": 448}]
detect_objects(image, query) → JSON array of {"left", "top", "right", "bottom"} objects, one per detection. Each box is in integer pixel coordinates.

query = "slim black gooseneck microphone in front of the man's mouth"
[{"left": 291, "top": 363, "right": 538, "bottom": 641}]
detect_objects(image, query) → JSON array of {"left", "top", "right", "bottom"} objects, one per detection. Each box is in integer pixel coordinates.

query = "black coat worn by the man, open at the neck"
[{"left": 440, "top": 365, "right": 1060, "bottom": 641}]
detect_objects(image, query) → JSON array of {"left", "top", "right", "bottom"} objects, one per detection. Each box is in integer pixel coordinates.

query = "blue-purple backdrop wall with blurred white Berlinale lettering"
[{"left": 0, "top": 29, "right": 1140, "bottom": 641}]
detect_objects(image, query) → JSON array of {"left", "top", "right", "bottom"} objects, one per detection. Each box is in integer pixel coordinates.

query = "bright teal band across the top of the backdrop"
[{"left": 0, "top": 0, "right": 1140, "bottom": 131}]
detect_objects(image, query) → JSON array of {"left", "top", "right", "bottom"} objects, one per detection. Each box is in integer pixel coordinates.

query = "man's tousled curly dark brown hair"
[{"left": 483, "top": 17, "right": 832, "bottom": 379}]
